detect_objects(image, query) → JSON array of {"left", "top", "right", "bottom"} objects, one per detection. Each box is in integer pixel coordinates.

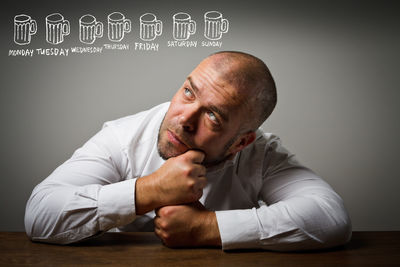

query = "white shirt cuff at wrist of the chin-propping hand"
[{"left": 98, "top": 179, "right": 136, "bottom": 231}]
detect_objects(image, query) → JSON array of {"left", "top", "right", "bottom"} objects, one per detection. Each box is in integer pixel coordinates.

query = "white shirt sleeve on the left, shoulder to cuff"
[{"left": 25, "top": 126, "right": 136, "bottom": 244}]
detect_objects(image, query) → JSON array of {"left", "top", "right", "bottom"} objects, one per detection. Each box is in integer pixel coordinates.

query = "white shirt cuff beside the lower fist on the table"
[{"left": 215, "top": 208, "right": 260, "bottom": 250}]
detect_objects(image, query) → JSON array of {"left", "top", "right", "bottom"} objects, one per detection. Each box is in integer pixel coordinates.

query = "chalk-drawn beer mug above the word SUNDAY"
[{"left": 204, "top": 11, "right": 229, "bottom": 40}]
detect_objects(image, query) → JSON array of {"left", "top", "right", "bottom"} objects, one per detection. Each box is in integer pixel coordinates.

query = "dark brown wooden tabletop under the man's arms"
[{"left": 0, "top": 232, "right": 400, "bottom": 267}]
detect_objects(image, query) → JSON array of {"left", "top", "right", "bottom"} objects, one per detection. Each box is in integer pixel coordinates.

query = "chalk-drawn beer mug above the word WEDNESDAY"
[{"left": 79, "top": 14, "right": 103, "bottom": 44}]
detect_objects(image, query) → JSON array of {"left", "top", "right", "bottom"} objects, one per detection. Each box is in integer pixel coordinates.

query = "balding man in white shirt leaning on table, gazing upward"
[{"left": 25, "top": 52, "right": 351, "bottom": 251}]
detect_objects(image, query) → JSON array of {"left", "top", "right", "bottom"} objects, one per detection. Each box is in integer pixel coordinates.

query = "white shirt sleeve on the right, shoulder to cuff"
[{"left": 216, "top": 135, "right": 351, "bottom": 251}]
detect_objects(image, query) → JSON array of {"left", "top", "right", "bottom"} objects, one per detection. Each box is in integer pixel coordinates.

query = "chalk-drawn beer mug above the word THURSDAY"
[{"left": 108, "top": 12, "right": 132, "bottom": 42}]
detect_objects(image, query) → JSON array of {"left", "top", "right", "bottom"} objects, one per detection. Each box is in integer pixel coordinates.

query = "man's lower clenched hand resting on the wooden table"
[{"left": 154, "top": 201, "right": 221, "bottom": 247}]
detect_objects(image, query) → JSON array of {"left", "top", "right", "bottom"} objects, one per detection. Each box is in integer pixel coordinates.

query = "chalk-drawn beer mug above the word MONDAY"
[{"left": 14, "top": 14, "right": 37, "bottom": 45}]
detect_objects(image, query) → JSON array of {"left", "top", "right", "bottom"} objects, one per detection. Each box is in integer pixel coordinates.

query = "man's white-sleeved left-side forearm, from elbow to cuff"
[{"left": 25, "top": 180, "right": 138, "bottom": 244}]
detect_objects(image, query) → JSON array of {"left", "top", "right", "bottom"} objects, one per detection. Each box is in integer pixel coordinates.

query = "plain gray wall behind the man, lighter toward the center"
[{"left": 0, "top": 0, "right": 400, "bottom": 231}]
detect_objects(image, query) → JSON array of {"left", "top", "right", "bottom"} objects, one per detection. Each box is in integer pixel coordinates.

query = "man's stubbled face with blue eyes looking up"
[{"left": 158, "top": 60, "right": 244, "bottom": 165}]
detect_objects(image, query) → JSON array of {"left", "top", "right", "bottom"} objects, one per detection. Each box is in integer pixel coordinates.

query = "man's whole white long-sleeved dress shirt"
[{"left": 25, "top": 103, "right": 351, "bottom": 251}]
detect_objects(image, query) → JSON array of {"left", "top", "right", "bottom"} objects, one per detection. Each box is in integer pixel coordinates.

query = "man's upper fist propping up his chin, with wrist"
[{"left": 135, "top": 150, "right": 207, "bottom": 214}]
